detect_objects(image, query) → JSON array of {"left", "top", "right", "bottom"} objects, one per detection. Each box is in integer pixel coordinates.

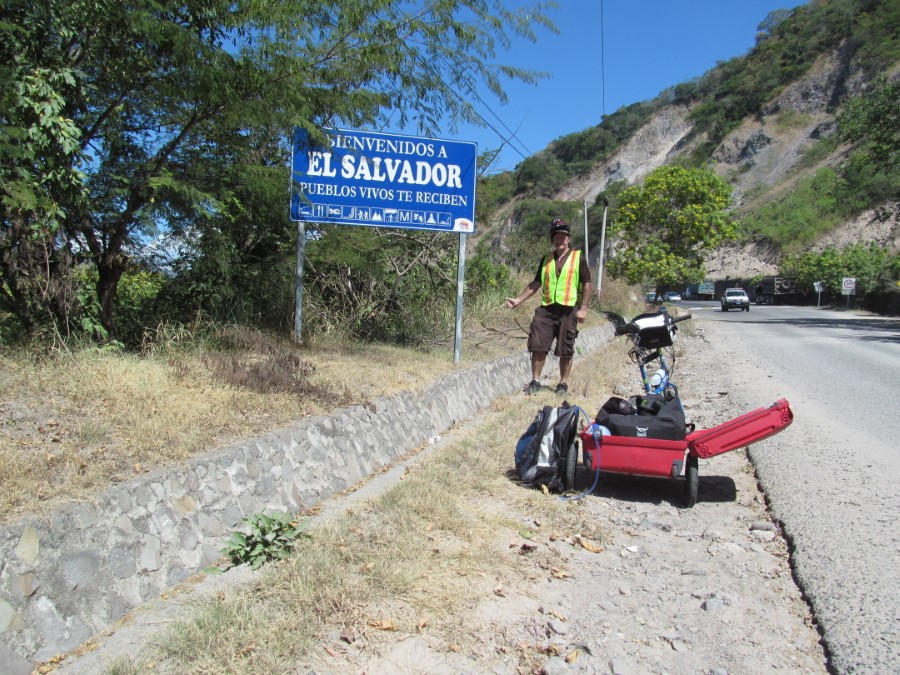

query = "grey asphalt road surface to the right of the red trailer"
[{"left": 680, "top": 302, "right": 900, "bottom": 674}]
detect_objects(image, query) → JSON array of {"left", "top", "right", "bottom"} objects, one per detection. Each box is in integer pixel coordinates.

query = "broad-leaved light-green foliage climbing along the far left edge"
[{"left": 0, "top": 2, "right": 83, "bottom": 333}]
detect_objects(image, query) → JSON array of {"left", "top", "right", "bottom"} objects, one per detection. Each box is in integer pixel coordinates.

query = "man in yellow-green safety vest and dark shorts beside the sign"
[{"left": 506, "top": 218, "right": 591, "bottom": 394}]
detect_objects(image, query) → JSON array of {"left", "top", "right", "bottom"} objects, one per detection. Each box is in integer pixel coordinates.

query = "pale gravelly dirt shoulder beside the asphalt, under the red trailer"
[{"left": 304, "top": 334, "right": 827, "bottom": 675}]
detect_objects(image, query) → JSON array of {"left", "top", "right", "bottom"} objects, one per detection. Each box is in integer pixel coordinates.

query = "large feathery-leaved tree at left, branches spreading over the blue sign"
[{"left": 0, "top": 0, "right": 554, "bottom": 336}]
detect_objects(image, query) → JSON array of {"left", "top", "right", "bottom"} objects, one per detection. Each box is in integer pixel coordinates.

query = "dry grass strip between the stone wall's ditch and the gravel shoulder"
[{"left": 128, "top": 347, "right": 623, "bottom": 673}]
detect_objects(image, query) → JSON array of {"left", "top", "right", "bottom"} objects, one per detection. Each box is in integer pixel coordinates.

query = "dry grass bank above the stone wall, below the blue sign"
[{"left": 0, "top": 283, "right": 636, "bottom": 522}]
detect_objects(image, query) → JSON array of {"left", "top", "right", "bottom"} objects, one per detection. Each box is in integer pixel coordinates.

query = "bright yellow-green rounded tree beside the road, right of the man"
[{"left": 609, "top": 166, "right": 737, "bottom": 292}]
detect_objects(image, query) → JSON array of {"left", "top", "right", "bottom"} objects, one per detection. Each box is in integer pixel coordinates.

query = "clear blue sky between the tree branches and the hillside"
[{"left": 458, "top": 0, "right": 806, "bottom": 173}]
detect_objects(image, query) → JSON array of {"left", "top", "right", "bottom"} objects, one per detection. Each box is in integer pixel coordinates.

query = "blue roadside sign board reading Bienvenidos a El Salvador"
[{"left": 291, "top": 129, "right": 477, "bottom": 234}]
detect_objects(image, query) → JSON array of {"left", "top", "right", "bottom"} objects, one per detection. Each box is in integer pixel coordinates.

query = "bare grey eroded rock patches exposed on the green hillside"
[{"left": 557, "top": 49, "right": 900, "bottom": 279}]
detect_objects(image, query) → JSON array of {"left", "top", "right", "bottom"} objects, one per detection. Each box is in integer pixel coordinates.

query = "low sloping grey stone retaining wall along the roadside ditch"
[{"left": 0, "top": 326, "right": 612, "bottom": 673}]
